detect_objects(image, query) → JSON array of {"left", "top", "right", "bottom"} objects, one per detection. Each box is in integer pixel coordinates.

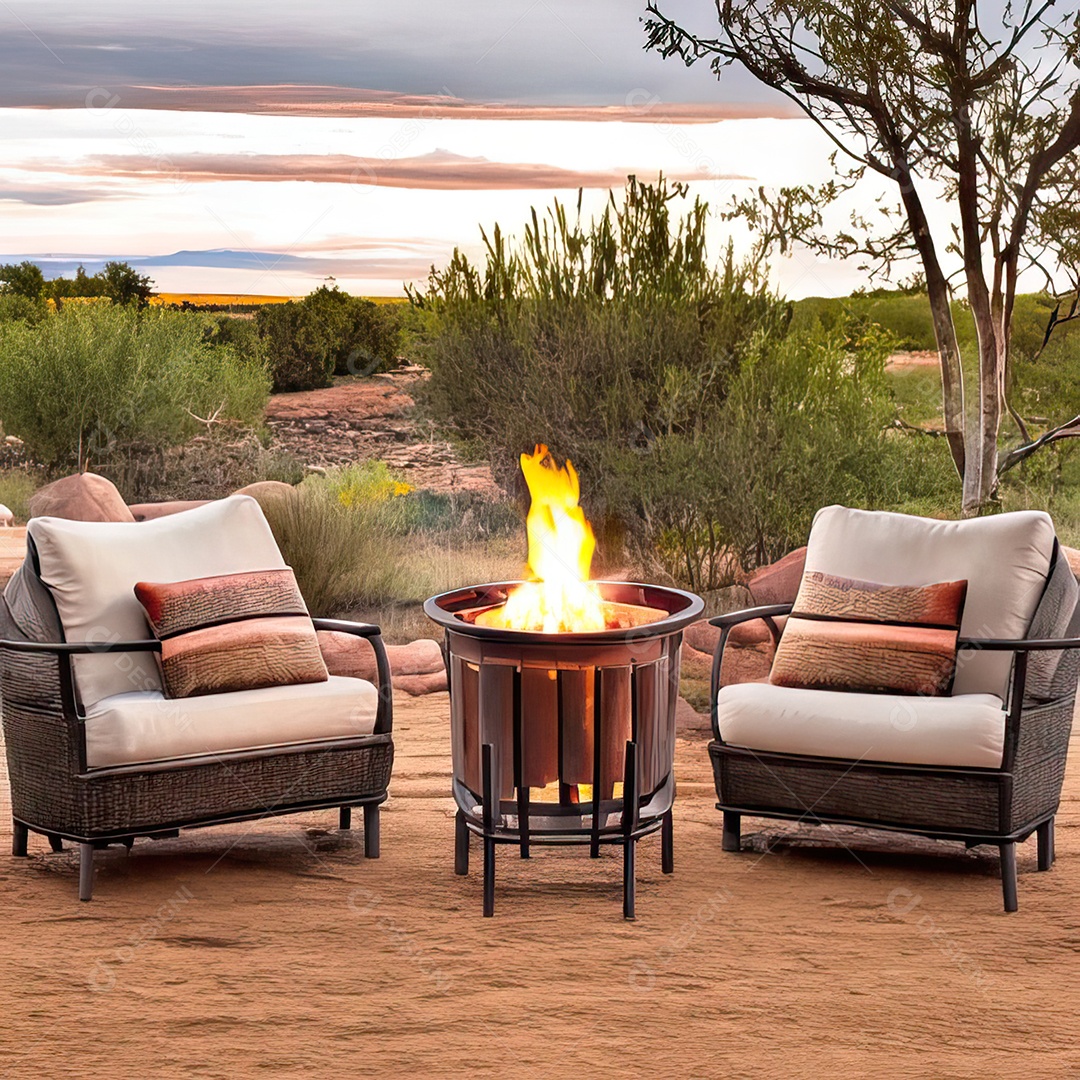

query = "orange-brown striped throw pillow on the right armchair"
[{"left": 769, "top": 571, "right": 968, "bottom": 697}]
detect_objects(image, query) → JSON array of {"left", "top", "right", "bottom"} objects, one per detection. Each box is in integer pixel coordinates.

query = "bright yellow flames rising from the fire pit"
[{"left": 485, "top": 446, "right": 607, "bottom": 634}]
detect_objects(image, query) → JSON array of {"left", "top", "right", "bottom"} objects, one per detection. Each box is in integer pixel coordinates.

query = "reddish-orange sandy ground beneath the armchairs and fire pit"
[{"left": 0, "top": 694, "right": 1080, "bottom": 1080}]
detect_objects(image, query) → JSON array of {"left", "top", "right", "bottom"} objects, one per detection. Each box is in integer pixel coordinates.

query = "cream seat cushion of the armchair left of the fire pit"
[{"left": 85, "top": 675, "right": 379, "bottom": 769}]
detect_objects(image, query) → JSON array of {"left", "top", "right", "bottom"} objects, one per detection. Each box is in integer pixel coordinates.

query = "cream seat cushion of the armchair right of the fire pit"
[{"left": 716, "top": 683, "right": 1005, "bottom": 769}]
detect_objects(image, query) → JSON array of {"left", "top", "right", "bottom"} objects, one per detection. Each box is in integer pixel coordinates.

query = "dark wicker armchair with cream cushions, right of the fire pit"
[{"left": 708, "top": 507, "right": 1080, "bottom": 912}]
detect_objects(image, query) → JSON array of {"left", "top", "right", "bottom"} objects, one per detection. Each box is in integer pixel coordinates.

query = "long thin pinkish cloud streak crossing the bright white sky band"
[{"left": 59, "top": 150, "right": 746, "bottom": 191}]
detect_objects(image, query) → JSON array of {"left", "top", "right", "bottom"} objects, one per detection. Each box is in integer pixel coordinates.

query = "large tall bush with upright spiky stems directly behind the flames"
[{"left": 411, "top": 177, "right": 787, "bottom": 498}]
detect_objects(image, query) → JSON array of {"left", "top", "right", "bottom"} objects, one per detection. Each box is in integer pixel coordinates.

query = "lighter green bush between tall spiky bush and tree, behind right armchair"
[{"left": 608, "top": 328, "right": 950, "bottom": 591}]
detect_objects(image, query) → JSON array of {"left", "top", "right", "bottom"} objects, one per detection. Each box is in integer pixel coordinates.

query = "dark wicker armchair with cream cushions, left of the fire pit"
[{"left": 0, "top": 497, "right": 393, "bottom": 900}]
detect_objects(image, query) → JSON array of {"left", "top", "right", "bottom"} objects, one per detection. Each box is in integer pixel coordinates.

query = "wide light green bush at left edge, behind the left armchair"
[{"left": 0, "top": 306, "right": 269, "bottom": 468}]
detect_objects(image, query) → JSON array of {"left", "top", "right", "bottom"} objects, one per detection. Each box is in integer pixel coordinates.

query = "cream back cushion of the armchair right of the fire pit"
[{"left": 805, "top": 507, "right": 1054, "bottom": 700}]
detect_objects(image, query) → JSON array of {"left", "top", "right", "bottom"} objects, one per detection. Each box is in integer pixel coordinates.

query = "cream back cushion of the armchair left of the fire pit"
[{"left": 27, "top": 495, "right": 285, "bottom": 706}]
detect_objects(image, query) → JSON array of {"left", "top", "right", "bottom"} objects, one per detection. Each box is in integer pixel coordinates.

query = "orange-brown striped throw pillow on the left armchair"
[{"left": 135, "top": 568, "right": 328, "bottom": 698}]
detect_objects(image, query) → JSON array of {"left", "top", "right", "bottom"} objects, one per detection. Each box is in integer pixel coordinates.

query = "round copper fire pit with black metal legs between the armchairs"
[{"left": 424, "top": 581, "right": 704, "bottom": 918}]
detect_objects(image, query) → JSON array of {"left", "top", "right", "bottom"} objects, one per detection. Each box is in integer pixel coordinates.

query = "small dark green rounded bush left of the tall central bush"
[{"left": 255, "top": 285, "right": 399, "bottom": 392}]
